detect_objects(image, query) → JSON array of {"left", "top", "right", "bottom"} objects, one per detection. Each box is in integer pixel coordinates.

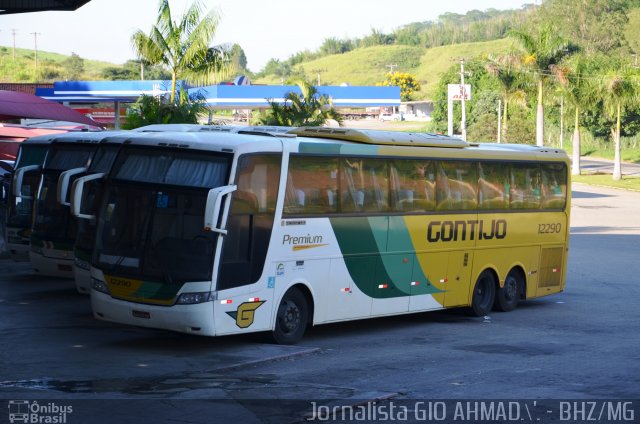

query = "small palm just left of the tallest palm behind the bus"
[{"left": 485, "top": 54, "right": 527, "bottom": 138}]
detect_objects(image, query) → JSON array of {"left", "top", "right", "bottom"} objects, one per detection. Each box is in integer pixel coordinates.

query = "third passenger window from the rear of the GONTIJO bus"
[{"left": 478, "top": 162, "right": 509, "bottom": 210}]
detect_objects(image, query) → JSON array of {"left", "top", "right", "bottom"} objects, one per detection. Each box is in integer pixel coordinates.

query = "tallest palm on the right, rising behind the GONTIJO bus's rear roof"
[{"left": 510, "top": 25, "right": 575, "bottom": 146}]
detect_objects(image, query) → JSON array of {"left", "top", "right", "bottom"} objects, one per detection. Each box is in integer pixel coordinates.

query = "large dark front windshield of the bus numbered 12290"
[{"left": 92, "top": 149, "right": 230, "bottom": 284}]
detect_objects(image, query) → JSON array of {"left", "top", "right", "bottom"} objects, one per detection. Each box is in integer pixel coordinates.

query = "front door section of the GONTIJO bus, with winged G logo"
[{"left": 214, "top": 154, "right": 282, "bottom": 334}]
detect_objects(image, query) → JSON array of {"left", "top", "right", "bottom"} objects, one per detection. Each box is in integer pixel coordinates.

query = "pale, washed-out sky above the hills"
[{"left": 0, "top": 0, "right": 535, "bottom": 72}]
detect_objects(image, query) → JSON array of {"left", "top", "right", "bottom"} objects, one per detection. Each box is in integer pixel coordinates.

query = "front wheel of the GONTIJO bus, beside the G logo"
[{"left": 271, "top": 287, "right": 309, "bottom": 344}]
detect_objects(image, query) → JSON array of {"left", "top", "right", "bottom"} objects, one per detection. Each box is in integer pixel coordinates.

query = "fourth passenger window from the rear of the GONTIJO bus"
[{"left": 436, "top": 161, "right": 478, "bottom": 210}]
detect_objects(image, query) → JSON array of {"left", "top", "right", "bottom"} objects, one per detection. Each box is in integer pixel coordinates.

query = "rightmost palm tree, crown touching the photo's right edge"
[{"left": 601, "top": 66, "right": 640, "bottom": 180}]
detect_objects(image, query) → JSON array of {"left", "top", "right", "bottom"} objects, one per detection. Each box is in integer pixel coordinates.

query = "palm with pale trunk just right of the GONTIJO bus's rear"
[{"left": 553, "top": 55, "right": 600, "bottom": 175}]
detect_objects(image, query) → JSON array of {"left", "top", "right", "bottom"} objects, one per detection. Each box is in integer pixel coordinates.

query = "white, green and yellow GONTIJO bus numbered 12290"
[{"left": 72, "top": 128, "right": 570, "bottom": 343}]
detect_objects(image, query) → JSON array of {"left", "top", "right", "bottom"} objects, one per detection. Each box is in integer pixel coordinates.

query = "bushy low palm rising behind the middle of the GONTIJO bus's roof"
[{"left": 255, "top": 80, "right": 343, "bottom": 127}]
